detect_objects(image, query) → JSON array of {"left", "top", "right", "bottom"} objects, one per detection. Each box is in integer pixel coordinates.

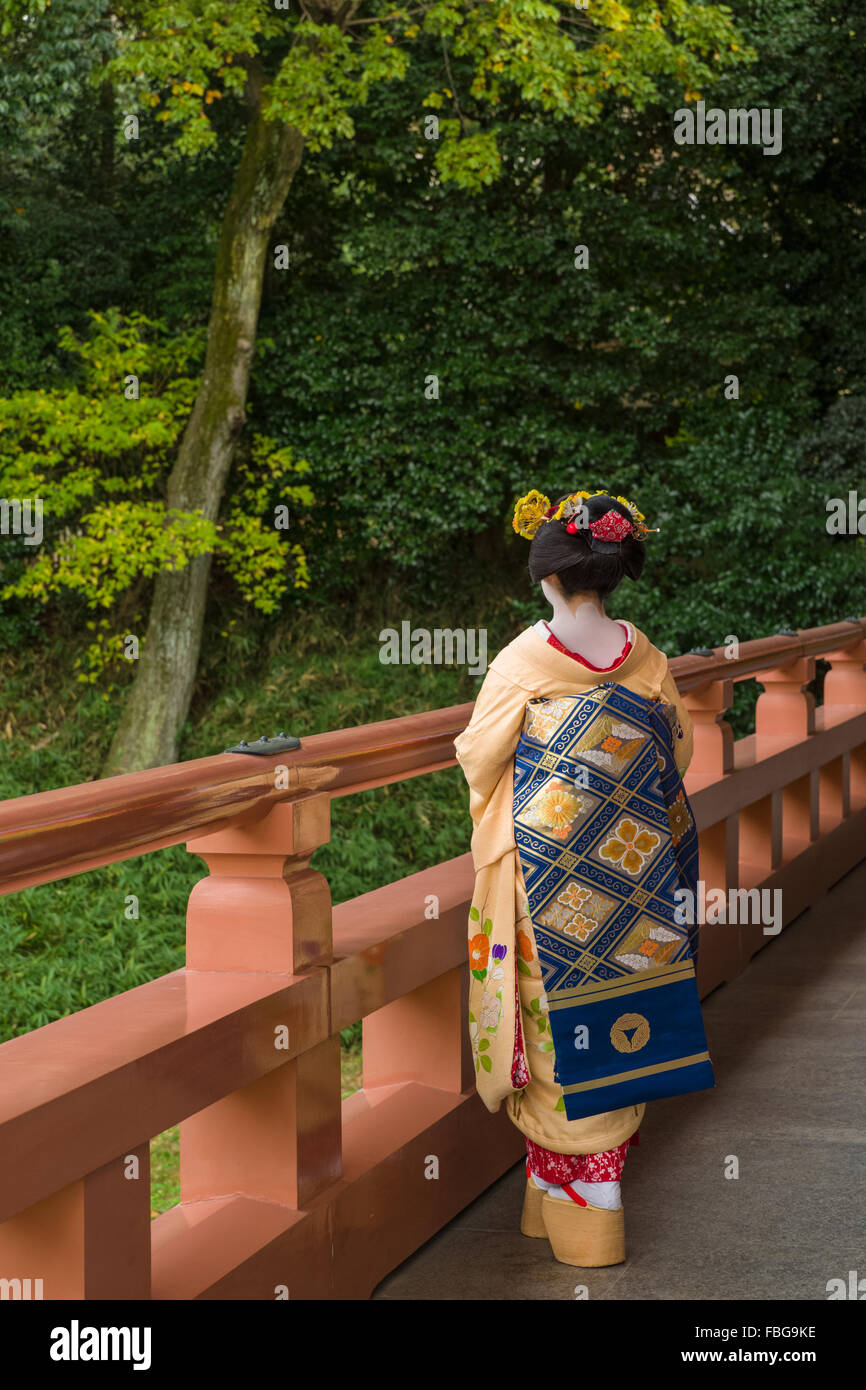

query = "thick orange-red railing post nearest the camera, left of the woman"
[{"left": 181, "top": 792, "right": 342, "bottom": 1208}]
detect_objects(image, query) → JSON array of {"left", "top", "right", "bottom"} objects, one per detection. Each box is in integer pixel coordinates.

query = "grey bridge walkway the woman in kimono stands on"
[{"left": 374, "top": 863, "right": 866, "bottom": 1300}]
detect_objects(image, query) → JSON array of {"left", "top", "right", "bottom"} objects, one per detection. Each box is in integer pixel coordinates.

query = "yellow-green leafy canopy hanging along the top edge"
[{"left": 104, "top": 0, "right": 753, "bottom": 190}]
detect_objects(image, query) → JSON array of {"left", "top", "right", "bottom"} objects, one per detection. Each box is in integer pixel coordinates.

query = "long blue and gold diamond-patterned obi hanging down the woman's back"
[{"left": 514, "top": 682, "right": 714, "bottom": 1120}]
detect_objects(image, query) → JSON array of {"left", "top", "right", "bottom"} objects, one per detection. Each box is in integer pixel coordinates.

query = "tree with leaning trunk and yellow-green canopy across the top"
[{"left": 0, "top": 0, "right": 745, "bottom": 773}]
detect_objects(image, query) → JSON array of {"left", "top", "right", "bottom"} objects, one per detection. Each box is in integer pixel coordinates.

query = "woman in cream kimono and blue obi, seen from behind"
[{"left": 455, "top": 492, "right": 713, "bottom": 1266}]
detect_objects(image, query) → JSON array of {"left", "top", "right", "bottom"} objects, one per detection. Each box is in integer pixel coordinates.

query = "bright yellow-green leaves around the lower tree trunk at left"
[{"left": 0, "top": 310, "right": 313, "bottom": 667}]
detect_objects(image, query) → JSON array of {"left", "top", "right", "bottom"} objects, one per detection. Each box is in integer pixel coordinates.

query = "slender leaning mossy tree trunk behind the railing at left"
[{"left": 103, "top": 93, "right": 303, "bottom": 777}]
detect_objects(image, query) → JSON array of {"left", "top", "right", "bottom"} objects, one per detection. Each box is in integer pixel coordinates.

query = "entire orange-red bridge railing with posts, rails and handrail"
[{"left": 0, "top": 620, "right": 866, "bottom": 1300}]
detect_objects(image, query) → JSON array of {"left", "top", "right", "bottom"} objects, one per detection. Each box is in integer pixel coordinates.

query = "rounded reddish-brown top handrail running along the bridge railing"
[{"left": 0, "top": 619, "right": 866, "bottom": 894}]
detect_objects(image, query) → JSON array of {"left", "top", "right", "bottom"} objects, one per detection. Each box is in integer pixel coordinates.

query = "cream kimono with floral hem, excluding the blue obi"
[{"left": 455, "top": 624, "right": 692, "bottom": 1154}]
